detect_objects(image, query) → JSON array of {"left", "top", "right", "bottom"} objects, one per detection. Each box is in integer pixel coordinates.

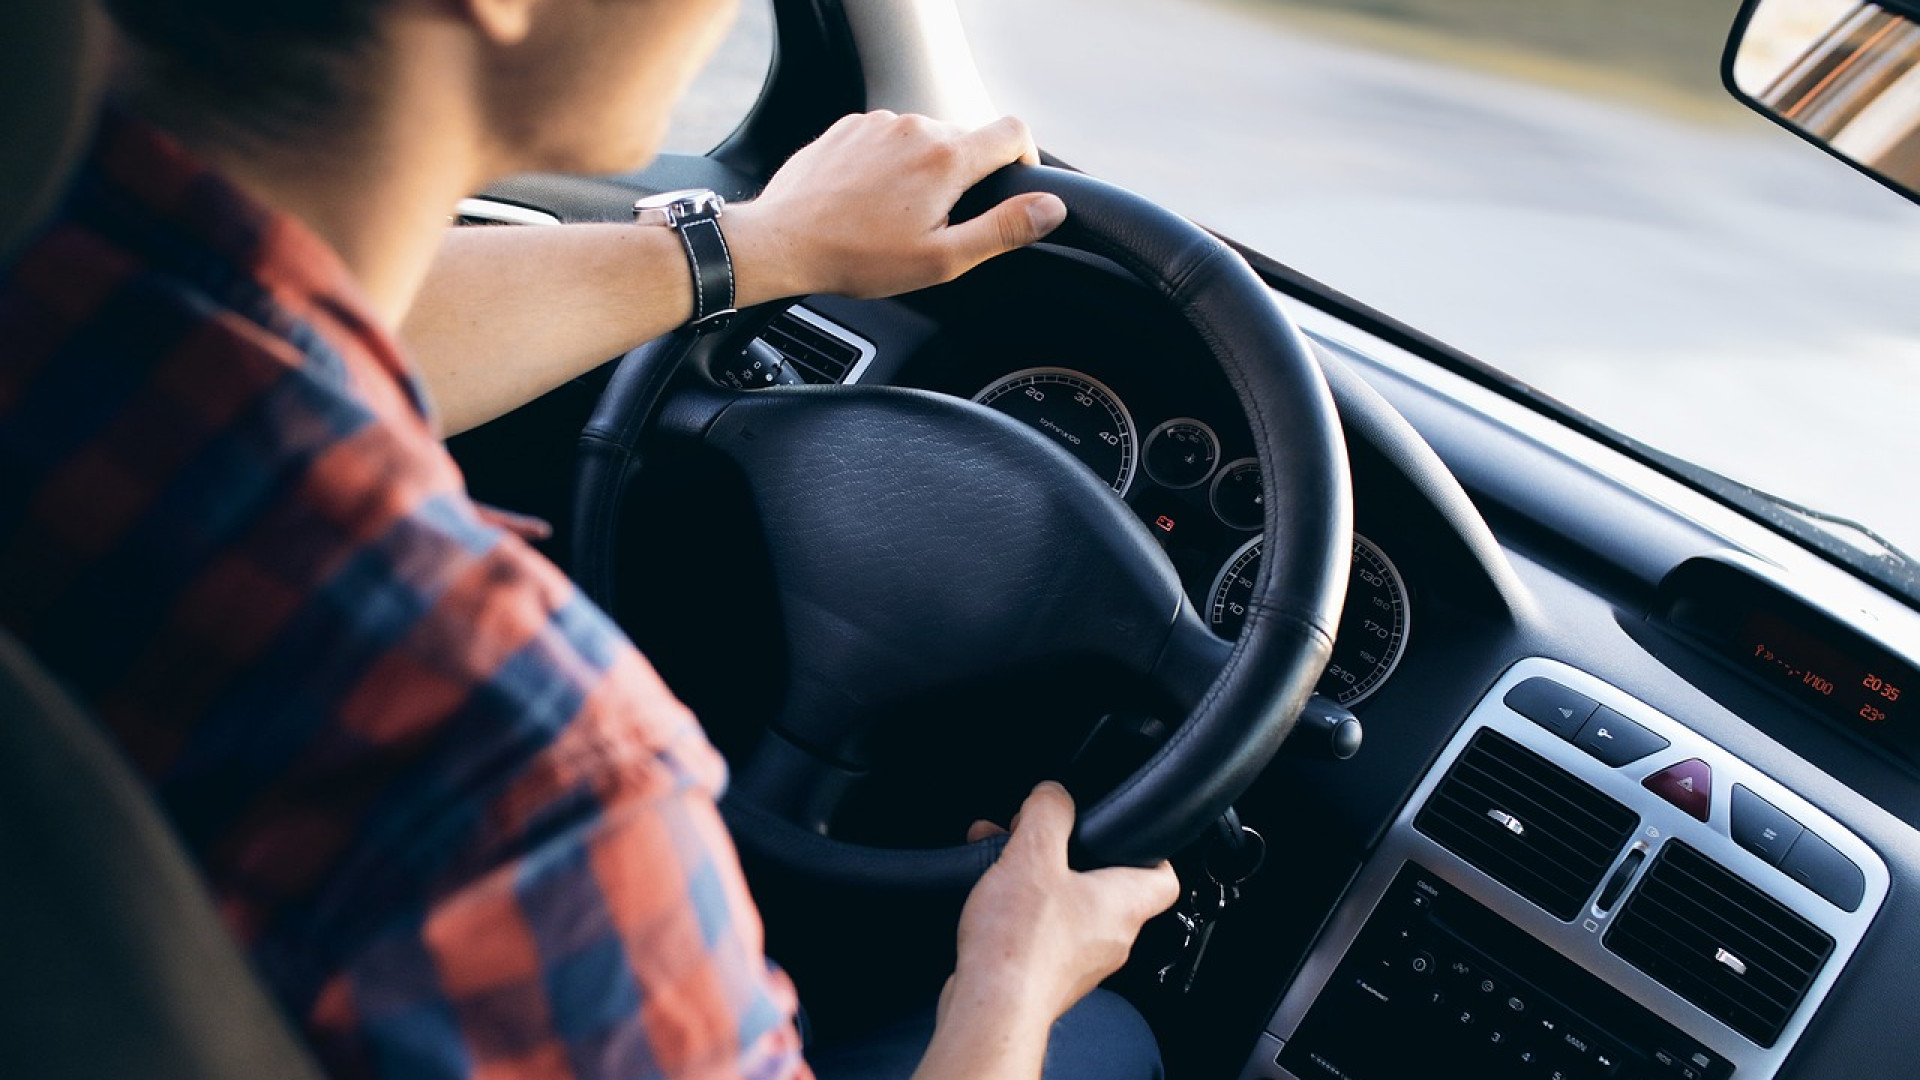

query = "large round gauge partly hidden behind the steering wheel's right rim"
[{"left": 1206, "top": 532, "right": 1407, "bottom": 707}]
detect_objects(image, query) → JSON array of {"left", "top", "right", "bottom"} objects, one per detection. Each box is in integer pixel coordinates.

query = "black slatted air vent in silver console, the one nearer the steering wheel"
[{"left": 1413, "top": 728, "right": 1640, "bottom": 910}]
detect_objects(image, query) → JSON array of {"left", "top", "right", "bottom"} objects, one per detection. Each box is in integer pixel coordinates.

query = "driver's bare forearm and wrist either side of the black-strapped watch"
[{"left": 401, "top": 206, "right": 799, "bottom": 434}]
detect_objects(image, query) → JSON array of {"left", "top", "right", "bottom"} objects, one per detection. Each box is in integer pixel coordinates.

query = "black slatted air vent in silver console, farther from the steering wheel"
[{"left": 1607, "top": 840, "right": 1834, "bottom": 1047}]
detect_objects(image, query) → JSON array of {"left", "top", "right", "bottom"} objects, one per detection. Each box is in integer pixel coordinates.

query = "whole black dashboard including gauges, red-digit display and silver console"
[{"left": 457, "top": 191, "right": 1920, "bottom": 1080}]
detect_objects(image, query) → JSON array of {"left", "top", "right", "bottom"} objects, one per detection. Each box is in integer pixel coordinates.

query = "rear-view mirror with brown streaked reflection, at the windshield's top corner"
[{"left": 1720, "top": 0, "right": 1920, "bottom": 202}]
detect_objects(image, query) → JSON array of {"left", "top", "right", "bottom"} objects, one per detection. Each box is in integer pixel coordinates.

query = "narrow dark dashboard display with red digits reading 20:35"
[{"left": 1732, "top": 611, "right": 1920, "bottom": 742}]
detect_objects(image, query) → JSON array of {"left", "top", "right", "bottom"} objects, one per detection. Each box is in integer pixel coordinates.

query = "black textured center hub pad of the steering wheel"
[{"left": 682, "top": 388, "right": 1185, "bottom": 753}]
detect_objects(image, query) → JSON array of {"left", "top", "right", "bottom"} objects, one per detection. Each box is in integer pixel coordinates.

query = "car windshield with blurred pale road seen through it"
[{"left": 960, "top": 0, "right": 1920, "bottom": 568}]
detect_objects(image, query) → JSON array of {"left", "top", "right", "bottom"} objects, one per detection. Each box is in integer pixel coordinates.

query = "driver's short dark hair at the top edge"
[{"left": 104, "top": 0, "right": 386, "bottom": 133}]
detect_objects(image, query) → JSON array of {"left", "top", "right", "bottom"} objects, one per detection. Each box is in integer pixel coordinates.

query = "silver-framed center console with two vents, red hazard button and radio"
[{"left": 1242, "top": 659, "right": 1889, "bottom": 1080}]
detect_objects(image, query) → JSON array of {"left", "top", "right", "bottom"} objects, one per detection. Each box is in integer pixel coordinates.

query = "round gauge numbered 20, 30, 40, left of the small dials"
[{"left": 973, "top": 367, "right": 1140, "bottom": 494}]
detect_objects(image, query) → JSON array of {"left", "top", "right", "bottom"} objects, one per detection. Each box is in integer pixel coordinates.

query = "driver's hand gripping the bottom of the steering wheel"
[{"left": 943, "top": 782, "right": 1179, "bottom": 1024}]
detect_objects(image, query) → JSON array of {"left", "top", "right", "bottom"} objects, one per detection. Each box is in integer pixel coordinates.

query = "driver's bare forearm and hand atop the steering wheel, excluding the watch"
[{"left": 403, "top": 111, "right": 1066, "bottom": 434}]
